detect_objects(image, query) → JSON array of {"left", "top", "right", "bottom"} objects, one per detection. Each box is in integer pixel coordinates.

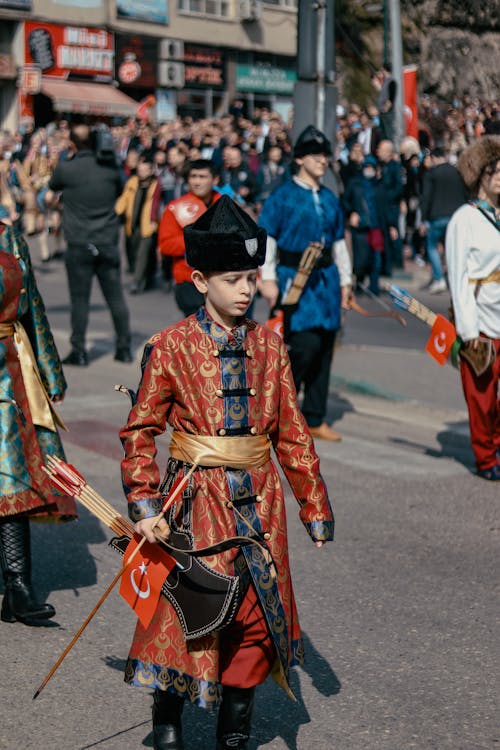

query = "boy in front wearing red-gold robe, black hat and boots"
[{"left": 120, "top": 196, "right": 334, "bottom": 750}]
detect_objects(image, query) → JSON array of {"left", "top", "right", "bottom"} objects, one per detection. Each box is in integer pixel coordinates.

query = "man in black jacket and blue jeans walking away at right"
[{"left": 420, "top": 147, "right": 467, "bottom": 294}]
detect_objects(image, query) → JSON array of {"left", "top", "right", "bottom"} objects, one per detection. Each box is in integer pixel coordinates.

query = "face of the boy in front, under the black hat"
[{"left": 192, "top": 269, "right": 257, "bottom": 328}]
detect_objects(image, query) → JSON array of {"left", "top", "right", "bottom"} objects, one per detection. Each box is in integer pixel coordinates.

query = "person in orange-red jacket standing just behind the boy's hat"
[{"left": 158, "top": 159, "right": 220, "bottom": 317}]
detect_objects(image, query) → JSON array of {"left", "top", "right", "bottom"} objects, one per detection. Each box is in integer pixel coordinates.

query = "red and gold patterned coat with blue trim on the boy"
[{"left": 120, "top": 308, "right": 333, "bottom": 705}]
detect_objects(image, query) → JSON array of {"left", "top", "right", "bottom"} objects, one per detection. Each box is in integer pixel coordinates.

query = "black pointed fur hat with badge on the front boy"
[{"left": 184, "top": 195, "right": 267, "bottom": 271}]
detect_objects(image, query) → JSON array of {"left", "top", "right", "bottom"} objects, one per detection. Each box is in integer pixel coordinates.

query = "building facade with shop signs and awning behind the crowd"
[{"left": 0, "top": 0, "right": 297, "bottom": 130}]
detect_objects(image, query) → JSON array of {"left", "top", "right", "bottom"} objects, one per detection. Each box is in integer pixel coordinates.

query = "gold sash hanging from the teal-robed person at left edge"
[{"left": 0, "top": 320, "right": 66, "bottom": 432}]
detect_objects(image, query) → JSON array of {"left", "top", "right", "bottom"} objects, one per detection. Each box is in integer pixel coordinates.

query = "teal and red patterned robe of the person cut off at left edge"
[{"left": 0, "top": 227, "right": 76, "bottom": 520}]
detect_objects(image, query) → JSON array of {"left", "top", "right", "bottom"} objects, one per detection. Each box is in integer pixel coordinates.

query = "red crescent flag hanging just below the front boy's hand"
[{"left": 120, "top": 534, "right": 175, "bottom": 628}]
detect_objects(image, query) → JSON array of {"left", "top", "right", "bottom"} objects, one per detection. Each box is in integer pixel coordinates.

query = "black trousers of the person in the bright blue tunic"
[{"left": 287, "top": 328, "right": 336, "bottom": 427}]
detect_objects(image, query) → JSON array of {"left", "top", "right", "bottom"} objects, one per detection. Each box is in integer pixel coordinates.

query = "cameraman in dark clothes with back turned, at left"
[{"left": 48, "top": 124, "right": 132, "bottom": 366}]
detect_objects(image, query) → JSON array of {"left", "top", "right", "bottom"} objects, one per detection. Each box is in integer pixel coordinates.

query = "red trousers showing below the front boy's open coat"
[{"left": 219, "top": 584, "right": 275, "bottom": 688}]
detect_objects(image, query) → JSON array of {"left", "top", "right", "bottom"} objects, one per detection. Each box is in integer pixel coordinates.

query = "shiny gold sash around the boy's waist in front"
[{"left": 170, "top": 430, "right": 271, "bottom": 469}]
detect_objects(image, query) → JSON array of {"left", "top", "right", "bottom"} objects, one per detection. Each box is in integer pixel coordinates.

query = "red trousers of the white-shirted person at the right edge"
[{"left": 460, "top": 339, "right": 500, "bottom": 470}]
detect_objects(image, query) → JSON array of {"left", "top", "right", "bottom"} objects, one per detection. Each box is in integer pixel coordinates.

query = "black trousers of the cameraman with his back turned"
[{"left": 65, "top": 242, "right": 130, "bottom": 352}]
